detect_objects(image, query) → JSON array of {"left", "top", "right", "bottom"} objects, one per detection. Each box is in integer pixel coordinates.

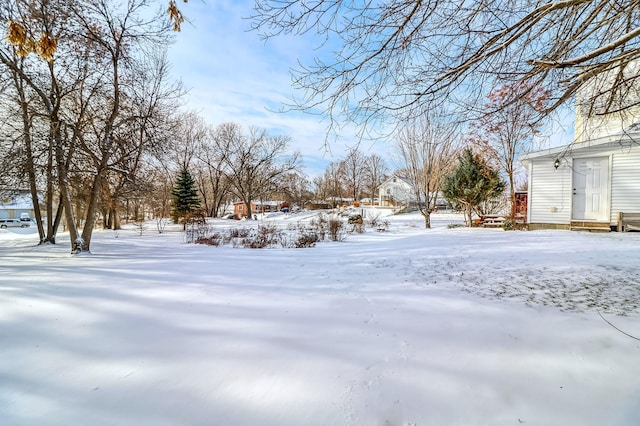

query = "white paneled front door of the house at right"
[{"left": 572, "top": 157, "right": 609, "bottom": 221}]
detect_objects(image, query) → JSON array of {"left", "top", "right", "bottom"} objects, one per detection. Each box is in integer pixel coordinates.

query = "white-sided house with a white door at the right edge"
[{"left": 520, "top": 67, "right": 640, "bottom": 231}]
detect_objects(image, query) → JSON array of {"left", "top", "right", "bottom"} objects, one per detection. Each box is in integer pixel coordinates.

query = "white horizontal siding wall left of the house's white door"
[{"left": 529, "top": 158, "right": 572, "bottom": 225}]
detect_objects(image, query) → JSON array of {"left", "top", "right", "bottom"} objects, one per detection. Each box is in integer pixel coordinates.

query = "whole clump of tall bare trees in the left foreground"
[{"left": 0, "top": 0, "right": 182, "bottom": 252}]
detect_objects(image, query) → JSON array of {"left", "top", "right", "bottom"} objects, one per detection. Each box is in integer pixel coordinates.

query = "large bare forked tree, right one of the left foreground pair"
[{"left": 71, "top": 0, "right": 175, "bottom": 251}]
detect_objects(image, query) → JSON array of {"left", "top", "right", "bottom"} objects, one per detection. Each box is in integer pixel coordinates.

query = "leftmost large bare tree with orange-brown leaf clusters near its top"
[{"left": 0, "top": 1, "right": 80, "bottom": 243}]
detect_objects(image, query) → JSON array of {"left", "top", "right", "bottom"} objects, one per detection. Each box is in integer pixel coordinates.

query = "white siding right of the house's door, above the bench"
[{"left": 611, "top": 147, "right": 640, "bottom": 223}]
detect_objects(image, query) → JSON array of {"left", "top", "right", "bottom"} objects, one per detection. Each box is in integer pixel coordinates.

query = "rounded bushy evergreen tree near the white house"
[{"left": 442, "top": 148, "right": 505, "bottom": 225}]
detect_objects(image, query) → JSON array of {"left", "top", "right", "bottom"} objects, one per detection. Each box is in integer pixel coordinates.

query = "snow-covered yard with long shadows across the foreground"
[{"left": 0, "top": 212, "right": 640, "bottom": 426}]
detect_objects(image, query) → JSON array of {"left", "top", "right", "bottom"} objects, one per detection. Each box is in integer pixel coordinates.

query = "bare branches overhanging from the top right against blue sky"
[{"left": 253, "top": 0, "right": 640, "bottom": 134}]
